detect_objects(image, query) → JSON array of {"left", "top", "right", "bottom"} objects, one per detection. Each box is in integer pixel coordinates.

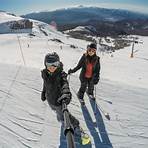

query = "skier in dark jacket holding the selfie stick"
[{"left": 41, "top": 52, "right": 80, "bottom": 130}]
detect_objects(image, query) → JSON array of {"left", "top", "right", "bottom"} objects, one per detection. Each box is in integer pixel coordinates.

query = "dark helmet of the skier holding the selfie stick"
[{"left": 44, "top": 52, "right": 60, "bottom": 68}]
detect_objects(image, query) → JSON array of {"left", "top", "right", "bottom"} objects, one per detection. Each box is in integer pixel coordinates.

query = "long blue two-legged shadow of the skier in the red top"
[{"left": 81, "top": 100, "right": 113, "bottom": 148}]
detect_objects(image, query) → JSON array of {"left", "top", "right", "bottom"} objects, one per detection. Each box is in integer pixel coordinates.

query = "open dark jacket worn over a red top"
[{"left": 71, "top": 54, "right": 100, "bottom": 81}]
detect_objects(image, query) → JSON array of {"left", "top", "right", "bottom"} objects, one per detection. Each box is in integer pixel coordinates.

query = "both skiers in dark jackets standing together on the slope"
[{"left": 41, "top": 43, "right": 100, "bottom": 134}]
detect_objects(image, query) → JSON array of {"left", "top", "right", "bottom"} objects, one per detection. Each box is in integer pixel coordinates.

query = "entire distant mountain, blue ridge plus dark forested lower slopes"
[{"left": 22, "top": 7, "right": 148, "bottom": 37}]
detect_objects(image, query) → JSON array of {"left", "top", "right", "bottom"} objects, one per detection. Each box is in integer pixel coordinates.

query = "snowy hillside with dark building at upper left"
[{"left": 0, "top": 12, "right": 63, "bottom": 36}]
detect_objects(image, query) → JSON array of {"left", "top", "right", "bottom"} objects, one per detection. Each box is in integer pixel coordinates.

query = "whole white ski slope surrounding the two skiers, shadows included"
[{"left": 0, "top": 11, "right": 148, "bottom": 148}]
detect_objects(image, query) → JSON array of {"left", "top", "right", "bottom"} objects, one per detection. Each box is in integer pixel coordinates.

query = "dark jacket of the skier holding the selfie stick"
[{"left": 41, "top": 65, "right": 71, "bottom": 106}]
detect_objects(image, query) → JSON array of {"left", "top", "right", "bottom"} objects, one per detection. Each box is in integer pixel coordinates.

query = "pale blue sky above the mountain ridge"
[{"left": 0, "top": 0, "right": 148, "bottom": 15}]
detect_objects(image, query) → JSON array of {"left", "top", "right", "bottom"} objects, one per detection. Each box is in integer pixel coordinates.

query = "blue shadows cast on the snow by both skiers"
[{"left": 59, "top": 100, "right": 113, "bottom": 148}]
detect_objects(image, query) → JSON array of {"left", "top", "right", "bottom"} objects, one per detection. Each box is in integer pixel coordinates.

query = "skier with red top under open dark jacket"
[{"left": 68, "top": 43, "right": 100, "bottom": 103}]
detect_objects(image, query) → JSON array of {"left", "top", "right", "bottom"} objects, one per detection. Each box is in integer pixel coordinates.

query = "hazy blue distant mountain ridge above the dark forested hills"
[{"left": 23, "top": 7, "right": 148, "bottom": 25}]
